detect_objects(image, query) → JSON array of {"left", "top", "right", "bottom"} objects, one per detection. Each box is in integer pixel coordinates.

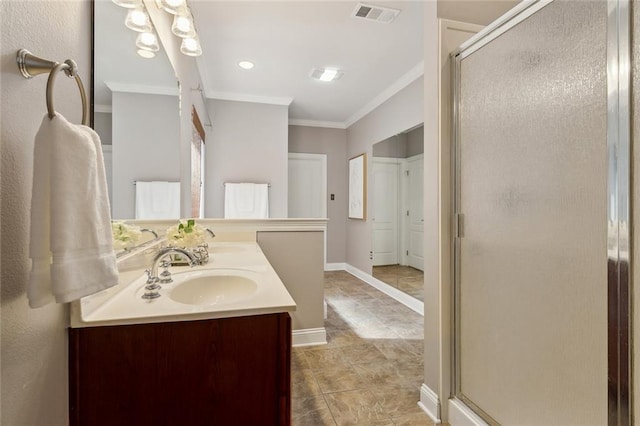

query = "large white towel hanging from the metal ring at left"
[{"left": 27, "top": 114, "right": 118, "bottom": 308}]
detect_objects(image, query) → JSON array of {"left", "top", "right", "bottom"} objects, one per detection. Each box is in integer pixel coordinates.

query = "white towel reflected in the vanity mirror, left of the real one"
[{"left": 135, "top": 181, "right": 180, "bottom": 219}]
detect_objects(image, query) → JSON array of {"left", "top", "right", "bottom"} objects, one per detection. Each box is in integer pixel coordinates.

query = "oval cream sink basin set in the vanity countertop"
[{"left": 169, "top": 270, "right": 258, "bottom": 305}]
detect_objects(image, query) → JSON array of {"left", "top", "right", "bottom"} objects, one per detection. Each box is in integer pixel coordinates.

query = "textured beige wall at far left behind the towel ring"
[{"left": 0, "top": 1, "right": 91, "bottom": 426}]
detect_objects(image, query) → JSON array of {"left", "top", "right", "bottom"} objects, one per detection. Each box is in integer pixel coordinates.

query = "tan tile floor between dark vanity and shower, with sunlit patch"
[{"left": 291, "top": 271, "right": 433, "bottom": 426}]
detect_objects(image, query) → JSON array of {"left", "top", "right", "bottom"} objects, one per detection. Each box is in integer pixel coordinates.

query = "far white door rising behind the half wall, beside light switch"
[{"left": 289, "top": 154, "right": 327, "bottom": 218}]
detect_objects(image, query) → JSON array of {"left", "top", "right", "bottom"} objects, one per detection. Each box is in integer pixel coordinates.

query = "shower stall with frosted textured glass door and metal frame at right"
[{"left": 452, "top": 0, "right": 640, "bottom": 425}]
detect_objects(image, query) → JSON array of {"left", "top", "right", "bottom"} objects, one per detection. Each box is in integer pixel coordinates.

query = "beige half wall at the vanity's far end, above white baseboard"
[{"left": 257, "top": 231, "right": 324, "bottom": 331}]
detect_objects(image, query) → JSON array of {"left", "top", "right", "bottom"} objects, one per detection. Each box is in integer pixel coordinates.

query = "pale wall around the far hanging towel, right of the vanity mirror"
[{"left": 205, "top": 100, "right": 288, "bottom": 218}]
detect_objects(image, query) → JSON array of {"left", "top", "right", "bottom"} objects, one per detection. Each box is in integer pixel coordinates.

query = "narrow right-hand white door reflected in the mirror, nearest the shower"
[{"left": 407, "top": 155, "right": 424, "bottom": 271}]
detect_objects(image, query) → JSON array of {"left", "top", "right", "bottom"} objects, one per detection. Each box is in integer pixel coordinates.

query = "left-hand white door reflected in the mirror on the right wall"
[{"left": 372, "top": 158, "right": 400, "bottom": 266}]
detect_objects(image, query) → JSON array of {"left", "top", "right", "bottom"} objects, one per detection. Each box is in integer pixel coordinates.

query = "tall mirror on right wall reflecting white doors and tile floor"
[{"left": 369, "top": 125, "right": 424, "bottom": 300}]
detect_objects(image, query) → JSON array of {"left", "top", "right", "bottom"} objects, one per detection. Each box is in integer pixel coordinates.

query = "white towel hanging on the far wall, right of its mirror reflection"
[{"left": 224, "top": 183, "right": 269, "bottom": 219}]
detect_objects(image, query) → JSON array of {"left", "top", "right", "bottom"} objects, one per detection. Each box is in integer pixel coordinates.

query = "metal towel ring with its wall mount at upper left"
[{"left": 16, "top": 49, "right": 89, "bottom": 126}]
